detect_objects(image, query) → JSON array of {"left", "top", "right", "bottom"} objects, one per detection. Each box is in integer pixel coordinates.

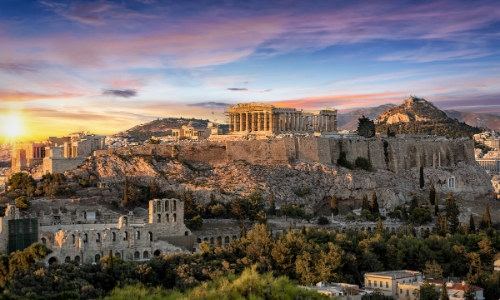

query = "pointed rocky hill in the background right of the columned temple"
[{"left": 376, "top": 96, "right": 481, "bottom": 138}]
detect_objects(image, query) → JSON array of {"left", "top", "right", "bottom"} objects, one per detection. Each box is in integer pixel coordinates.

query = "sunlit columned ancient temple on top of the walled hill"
[{"left": 227, "top": 102, "right": 337, "bottom": 135}]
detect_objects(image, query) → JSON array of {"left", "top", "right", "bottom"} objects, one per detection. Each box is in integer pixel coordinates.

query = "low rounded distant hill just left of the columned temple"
[{"left": 116, "top": 118, "right": 209, "bottom": 141}]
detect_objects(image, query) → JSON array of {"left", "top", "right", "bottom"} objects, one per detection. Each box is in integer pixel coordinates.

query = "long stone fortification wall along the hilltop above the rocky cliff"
[{"left": 94, "top": 137, "right": 475, "bottom": 172}]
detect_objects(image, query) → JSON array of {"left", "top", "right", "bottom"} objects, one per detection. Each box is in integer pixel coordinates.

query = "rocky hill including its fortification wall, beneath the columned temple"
[{"left": 81, "top": 137, "right": 492, "bottom": 212}]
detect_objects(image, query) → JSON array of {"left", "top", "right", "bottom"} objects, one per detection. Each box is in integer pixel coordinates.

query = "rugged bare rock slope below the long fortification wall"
[{"left": 74, "top": 141, "right": 492, "bottom": 212}]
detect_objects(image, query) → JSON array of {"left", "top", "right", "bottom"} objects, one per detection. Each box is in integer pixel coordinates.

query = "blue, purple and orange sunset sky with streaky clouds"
[{"left": 0, "top": 0, "right": 500, "bottom": 139}]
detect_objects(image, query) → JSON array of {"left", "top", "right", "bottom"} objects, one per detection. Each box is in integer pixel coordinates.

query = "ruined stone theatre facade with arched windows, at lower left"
[{"left": 0, "top": 199, "right": 196, "bottom": 264}]
